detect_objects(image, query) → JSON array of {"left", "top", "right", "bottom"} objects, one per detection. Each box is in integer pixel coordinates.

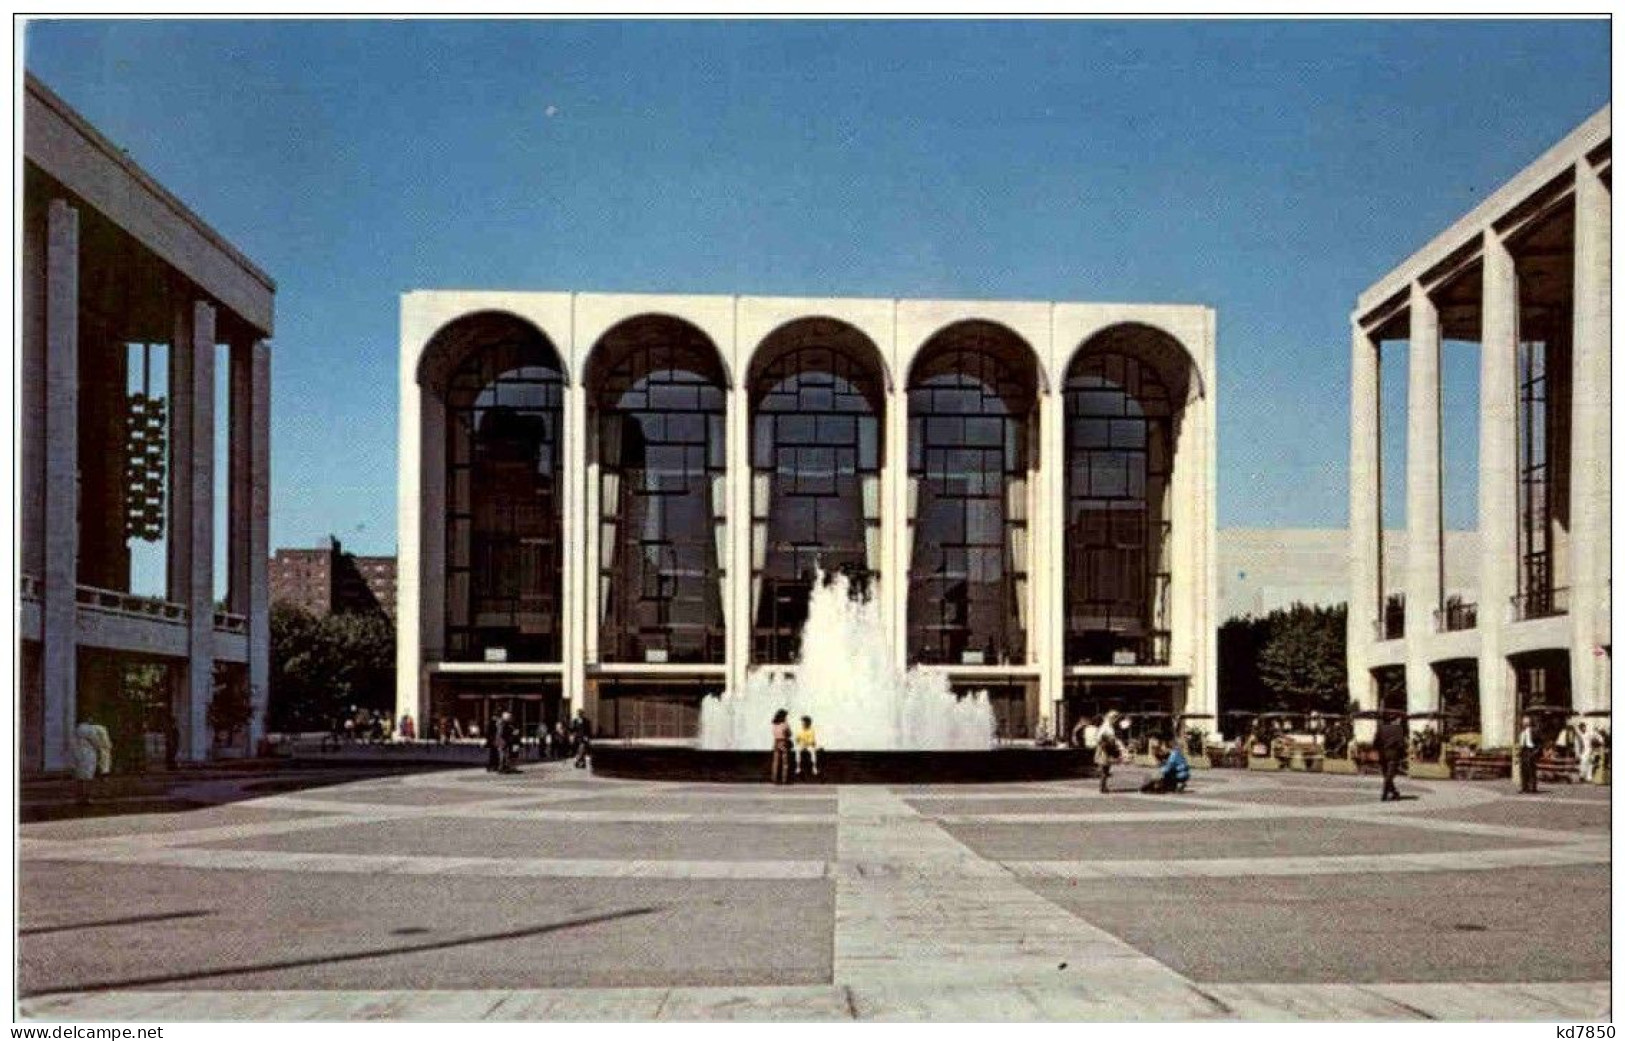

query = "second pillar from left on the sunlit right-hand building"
[{"left": 1406, "top": 284, "right": 1445, "bottom": 729}]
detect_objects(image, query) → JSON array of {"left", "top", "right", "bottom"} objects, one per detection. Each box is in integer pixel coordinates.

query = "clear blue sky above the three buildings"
[{"left": 24, "top": 19, "right": 1609, "bottom": 584}]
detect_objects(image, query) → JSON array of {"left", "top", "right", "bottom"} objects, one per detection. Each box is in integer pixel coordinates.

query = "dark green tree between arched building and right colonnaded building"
[{"left": 1258, "top": 604, "right": 1349, "bottom": 713}]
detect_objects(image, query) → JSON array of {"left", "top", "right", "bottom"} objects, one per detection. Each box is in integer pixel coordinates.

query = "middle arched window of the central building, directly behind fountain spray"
[{"left": 751, "top": 318, "right": 884, "bottom": 664}]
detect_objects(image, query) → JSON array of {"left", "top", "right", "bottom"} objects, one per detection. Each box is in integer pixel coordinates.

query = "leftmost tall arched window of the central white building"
[{"left": 445, "top": 336, "right": 564, "bottom": 661}]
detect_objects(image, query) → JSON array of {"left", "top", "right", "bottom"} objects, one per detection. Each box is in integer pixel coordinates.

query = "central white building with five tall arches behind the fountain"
[{"left": 397, "top": 292, "right": 1216, "bottom": 739}]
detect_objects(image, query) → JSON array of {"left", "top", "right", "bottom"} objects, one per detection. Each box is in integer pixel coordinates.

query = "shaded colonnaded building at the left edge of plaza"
[{"left": 18, "top": 76, "right": 275, "bottom": 773}]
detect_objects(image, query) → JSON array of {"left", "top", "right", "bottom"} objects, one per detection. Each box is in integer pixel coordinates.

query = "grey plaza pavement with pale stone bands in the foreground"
[{"left": 18, "top": 750, "right": 1612, "bottom": 1022}]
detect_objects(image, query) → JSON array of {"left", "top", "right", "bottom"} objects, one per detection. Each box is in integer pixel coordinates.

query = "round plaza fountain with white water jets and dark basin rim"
[{"left": 593, "top": 573, "right": 1087, "bottom": 783}]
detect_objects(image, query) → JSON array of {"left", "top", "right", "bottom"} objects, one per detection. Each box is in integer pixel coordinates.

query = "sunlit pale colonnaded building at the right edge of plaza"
[{"left": 1349, "top": 107, "right": 1614, "bottom": 745}]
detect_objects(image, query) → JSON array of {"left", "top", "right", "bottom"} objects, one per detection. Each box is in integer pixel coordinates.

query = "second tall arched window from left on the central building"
[{"left": 590, "top": 317, "right": 728, "bottom": 663}]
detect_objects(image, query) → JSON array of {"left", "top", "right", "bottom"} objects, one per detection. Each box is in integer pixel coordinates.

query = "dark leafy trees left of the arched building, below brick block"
[{"left": 270, "top": 603, "right": 395, "bottom": 731}]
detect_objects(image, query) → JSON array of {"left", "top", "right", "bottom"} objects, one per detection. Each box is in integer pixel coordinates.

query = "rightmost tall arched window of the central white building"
[{"left": 1064, "top": 344, "right": 1177, "bottom": 664}]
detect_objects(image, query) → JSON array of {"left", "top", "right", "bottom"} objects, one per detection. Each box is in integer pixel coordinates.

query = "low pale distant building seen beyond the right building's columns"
[{"left": 1214, "top": 528, "right": 1479, "bottom": 625}]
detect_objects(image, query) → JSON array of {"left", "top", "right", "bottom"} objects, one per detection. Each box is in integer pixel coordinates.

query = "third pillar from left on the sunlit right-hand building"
[{"left": 1479, "top": 231, "right": 1518, "bottom": 745}]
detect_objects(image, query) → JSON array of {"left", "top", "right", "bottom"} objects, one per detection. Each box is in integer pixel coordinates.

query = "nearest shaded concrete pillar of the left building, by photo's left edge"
[{"left": 39, "top": 200, "right": 80, "bottom": 770}]
